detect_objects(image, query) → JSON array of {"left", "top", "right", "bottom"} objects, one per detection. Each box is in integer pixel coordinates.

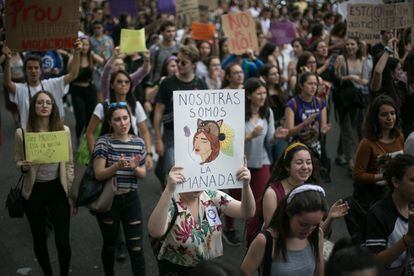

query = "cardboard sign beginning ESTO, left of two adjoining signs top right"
[{"left": 347, "top": 4, "right": 381, "bottom": 43}]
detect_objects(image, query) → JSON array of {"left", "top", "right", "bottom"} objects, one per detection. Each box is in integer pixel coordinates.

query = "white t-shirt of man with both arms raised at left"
[{"left": 9, "top": 76, "right": 68, "bottom": 128}]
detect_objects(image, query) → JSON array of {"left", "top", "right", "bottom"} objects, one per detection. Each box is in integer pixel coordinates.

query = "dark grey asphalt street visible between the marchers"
[{"left": 0, "top": 95, "right": 352, "bottom": 276}]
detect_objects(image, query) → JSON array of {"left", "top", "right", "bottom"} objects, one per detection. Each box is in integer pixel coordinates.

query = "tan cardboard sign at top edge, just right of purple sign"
[{"left": 175, "top": 0, "right": 200, "bottom": 29}]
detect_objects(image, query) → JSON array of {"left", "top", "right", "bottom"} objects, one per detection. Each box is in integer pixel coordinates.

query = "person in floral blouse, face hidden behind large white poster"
[{"left": 148, "top": 167, "right": 255, "bottom": 276}]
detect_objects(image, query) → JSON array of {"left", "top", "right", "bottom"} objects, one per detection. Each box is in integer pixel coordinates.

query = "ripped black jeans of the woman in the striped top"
[{"left": 94, "top": 191, "right": 145, "bottom": 276}]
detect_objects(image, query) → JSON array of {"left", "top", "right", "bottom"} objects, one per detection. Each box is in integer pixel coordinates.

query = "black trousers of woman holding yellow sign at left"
[{"left": 23, "top": 179, "right": 71, "bottom": 276}]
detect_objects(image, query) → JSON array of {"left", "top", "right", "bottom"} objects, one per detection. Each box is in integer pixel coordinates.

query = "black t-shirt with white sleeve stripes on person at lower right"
[{"left": 365, "top": 193, "right": 408, "bottom": 270}]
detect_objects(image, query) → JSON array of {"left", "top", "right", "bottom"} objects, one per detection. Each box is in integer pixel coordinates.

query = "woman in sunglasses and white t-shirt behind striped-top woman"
[{"left": 86, "top": 70, "right": 152, "bottom": 170}]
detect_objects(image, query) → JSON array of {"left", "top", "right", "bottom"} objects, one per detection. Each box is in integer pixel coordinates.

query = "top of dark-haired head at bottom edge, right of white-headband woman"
[{"left": 325, "top": 238, "right": 378, "bottom": 276}]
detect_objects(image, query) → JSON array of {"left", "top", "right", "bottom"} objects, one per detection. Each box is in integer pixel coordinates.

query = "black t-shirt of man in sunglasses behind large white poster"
[{"left": 155, "top": 75, "right": 208, "bottom": 130}]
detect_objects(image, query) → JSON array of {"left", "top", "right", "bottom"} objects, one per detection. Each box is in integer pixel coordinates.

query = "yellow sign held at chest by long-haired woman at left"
[{"left": 24, "top": 131, "right": 69, "bottom": 164}]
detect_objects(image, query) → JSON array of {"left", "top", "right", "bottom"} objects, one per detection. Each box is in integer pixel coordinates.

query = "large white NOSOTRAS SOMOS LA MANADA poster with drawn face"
[{"left": 173, "top": 90, "right": 245, "bottom": 192}]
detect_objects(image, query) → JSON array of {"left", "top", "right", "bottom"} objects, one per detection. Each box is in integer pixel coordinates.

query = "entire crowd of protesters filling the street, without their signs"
[{"left": 0, "top": 0, "right": 414, "bottom": 276}]
